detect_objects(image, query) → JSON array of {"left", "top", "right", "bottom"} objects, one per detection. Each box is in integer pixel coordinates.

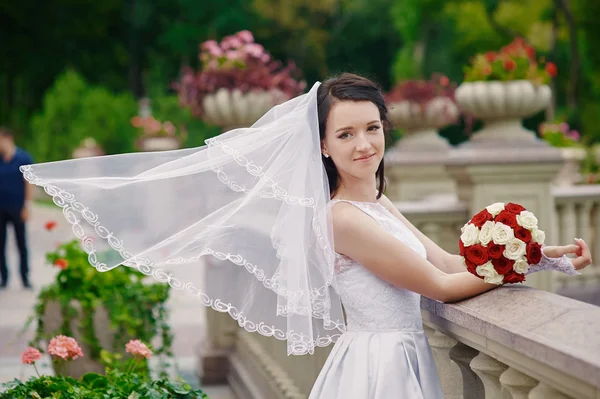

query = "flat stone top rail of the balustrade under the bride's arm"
[{"left": 421, "top": 286, "right": 600, "bottom": 390}]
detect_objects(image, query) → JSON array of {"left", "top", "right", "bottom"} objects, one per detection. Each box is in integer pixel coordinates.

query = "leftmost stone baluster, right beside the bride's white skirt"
[{"left": 423, "top": 326, "right": 463, "bottom": 399}]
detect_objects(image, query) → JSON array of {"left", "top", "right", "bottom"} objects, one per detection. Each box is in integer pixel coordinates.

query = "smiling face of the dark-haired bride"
[{"left": 321, "top": 101, "right": 385, "bottom": 184}]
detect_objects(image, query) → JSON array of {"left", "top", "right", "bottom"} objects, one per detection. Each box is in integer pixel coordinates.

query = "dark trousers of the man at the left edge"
[{"left": 0, "top": 210, "right": 29, "bottom": 285}]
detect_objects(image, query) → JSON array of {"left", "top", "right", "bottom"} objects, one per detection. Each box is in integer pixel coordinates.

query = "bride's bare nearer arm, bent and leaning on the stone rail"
[{"left": 332, "top": 202, "right": 498, "bottom": 302}]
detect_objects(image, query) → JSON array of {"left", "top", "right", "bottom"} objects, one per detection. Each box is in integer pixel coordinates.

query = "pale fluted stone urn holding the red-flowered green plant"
[{"left": 455, "top": 80, "right": 552, "bottom": 143}]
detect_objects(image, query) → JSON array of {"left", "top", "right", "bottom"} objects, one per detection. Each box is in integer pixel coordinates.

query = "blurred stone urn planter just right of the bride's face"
[{"left": 388, "top": 96, "right": 460, "bottom": 151}]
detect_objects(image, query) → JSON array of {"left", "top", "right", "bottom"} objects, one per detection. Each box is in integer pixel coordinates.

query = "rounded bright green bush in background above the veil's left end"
[{"left": 31, "top": 70, "right": 137, "bottom": 162}]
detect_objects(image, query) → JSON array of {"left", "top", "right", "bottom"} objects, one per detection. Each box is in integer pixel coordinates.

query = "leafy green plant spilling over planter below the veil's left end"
[{"left": 25, "top": 240, "right": 173, "bottom": 368}]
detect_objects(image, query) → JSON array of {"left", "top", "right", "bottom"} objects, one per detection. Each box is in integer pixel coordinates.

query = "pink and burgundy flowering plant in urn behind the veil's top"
[{"left": 174, "top": 30, "right": 306, "bottom": 116}]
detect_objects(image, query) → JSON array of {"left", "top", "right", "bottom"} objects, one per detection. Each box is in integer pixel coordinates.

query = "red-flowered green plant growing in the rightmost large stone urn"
[{"left": 465, "top": 38, "right": 558, "bottom": 85}]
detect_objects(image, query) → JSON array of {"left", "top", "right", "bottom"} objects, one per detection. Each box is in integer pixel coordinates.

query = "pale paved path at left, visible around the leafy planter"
[{"left": 0, "top": 205, "right": 234, "bottom": 399}]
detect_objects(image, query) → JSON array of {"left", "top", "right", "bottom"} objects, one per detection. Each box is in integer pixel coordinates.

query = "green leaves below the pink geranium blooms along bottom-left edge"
[{"left": 0, "top": 370, "right": 208, "bottom": 399}]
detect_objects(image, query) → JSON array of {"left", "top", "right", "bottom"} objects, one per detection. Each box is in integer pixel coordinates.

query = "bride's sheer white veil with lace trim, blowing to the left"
[{"left": 21, "top": 83, "right": 344, "bottom": 355}]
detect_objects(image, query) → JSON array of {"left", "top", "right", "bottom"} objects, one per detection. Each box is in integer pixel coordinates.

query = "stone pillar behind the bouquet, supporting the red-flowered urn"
[{"left": 448, "top": 138, "right": 563, "bottom": 291}]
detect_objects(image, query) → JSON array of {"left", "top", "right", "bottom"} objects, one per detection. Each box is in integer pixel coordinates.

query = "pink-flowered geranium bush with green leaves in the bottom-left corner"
[{"left": 0, "top": 336, "right": 208, "bottom": 399}]
